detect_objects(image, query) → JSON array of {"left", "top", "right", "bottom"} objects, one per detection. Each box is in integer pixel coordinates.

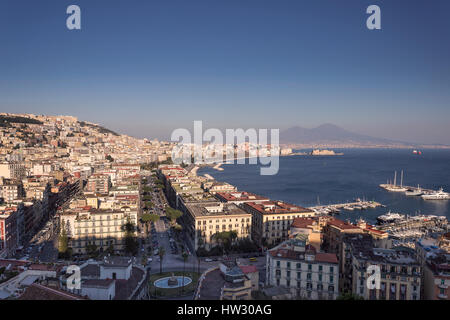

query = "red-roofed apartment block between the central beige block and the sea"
[{"left": 242, "top": 201, "right": 315, "bottom": 246}]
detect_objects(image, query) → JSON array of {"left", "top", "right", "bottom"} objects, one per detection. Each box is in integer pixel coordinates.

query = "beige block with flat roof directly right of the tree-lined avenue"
[{"left": 184, "top": 202, "right": 252, "bottom": 250}]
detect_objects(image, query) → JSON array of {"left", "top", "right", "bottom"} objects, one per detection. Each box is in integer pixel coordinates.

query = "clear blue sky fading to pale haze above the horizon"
[{"left": 0, "top": 0, "right": 450, "bottom": 144}]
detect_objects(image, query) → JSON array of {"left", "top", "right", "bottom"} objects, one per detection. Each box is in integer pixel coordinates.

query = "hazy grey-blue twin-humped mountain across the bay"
[{"left": 280, "top": 123, "right": 412, "bottom": 147}]
